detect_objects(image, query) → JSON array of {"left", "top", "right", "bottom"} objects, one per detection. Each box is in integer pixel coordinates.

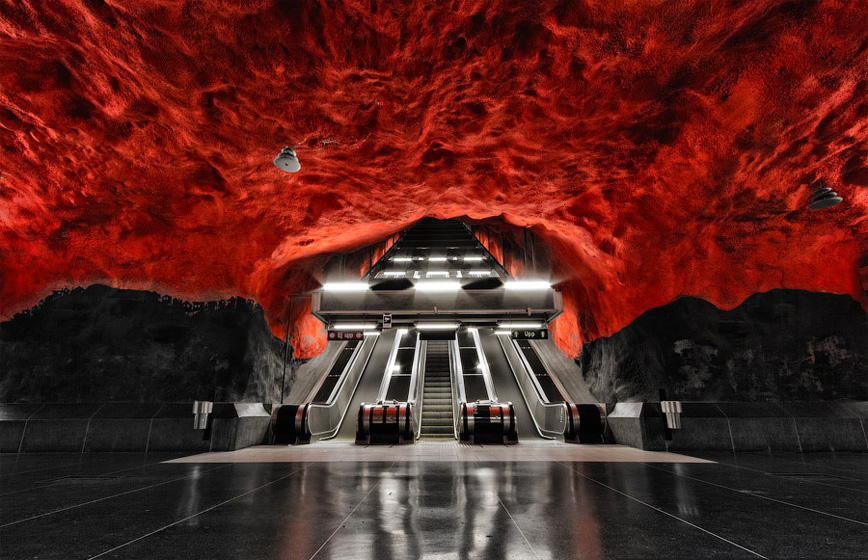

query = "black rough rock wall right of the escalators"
[{"left": 576, "top": 289, "right": 868, "bottom": 402}]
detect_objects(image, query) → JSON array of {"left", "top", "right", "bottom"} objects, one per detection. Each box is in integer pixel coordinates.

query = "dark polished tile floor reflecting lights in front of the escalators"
[{"left": 0, "top": 446, "right": 868, "bottom": 560}]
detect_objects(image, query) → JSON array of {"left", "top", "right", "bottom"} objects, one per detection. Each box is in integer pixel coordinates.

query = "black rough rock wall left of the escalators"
[{"left": 0, "top": 285, "right": 284, "bottom": 402}]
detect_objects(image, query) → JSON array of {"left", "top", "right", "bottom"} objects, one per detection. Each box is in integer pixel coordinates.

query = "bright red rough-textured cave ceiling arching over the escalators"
[{"left": 0, "top": 0, "right": 868, "bottom": 354}]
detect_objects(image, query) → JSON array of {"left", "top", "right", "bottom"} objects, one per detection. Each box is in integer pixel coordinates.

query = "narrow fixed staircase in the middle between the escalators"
[{"left": 421, "top": 340, "right": 455, "bottom": 439}]
